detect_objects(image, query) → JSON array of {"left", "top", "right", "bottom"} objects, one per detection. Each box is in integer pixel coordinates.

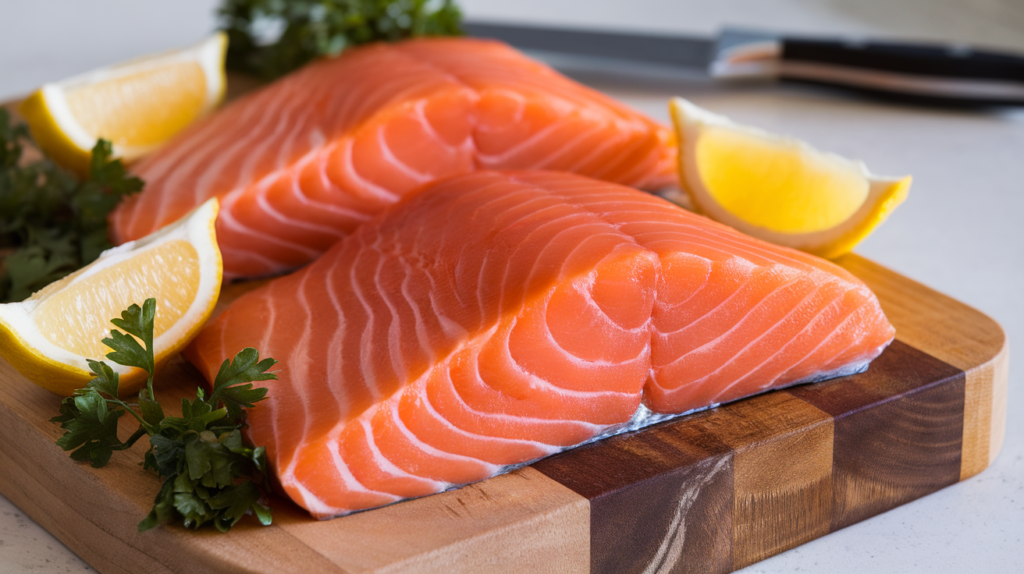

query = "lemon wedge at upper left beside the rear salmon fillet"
[{"left": 18, "top": 33, "right": 227, "bottom": 175}]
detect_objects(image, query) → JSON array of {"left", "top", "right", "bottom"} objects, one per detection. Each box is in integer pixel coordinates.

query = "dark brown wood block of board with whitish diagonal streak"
[{"left": 534, "top": 411, "right": 733, "bottom": 573}]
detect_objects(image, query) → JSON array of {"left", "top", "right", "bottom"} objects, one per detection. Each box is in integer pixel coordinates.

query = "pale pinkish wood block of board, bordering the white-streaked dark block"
[{"left": 276, "top": 468, "right": 590, "bottom": 573}]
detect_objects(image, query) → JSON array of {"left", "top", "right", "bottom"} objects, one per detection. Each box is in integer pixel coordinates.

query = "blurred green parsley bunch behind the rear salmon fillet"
[{"left": 219, "top": 0, "right": 462, "bottom": 80}]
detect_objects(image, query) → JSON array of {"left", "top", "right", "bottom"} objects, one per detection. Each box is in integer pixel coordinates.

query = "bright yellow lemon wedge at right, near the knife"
[{"left": 670, "top": 98, "right": 910, "bottom": 259}]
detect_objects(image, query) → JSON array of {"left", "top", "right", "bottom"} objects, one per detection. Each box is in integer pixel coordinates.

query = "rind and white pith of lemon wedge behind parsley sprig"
[{"left": 0, "top": 198, "right": 223, "bottom": 396}]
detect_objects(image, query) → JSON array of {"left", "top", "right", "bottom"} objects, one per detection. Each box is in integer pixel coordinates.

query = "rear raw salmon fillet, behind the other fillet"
[{"left": 111, "top": 38, "right": 675, "bottom": 277}]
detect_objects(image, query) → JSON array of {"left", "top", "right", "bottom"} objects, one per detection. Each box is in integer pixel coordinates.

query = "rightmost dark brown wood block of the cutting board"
[{"left": 788, "top": 341, "right": 965, "bottom": 530}]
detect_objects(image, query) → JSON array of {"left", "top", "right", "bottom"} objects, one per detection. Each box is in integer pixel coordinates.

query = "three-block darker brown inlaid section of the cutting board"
[{"left": 532, "top": 341, "right": 965, "bottom": 573}]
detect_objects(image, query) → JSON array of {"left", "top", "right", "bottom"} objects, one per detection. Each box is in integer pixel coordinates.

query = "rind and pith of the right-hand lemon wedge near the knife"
[{"left": 669, "top": 97, "right": 911, "bottom": 259}]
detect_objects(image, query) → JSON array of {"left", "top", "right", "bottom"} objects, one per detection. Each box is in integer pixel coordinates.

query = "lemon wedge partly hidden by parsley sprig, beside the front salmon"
[{"left": 0, "top": 198, "right": 222, "bottom": 396}]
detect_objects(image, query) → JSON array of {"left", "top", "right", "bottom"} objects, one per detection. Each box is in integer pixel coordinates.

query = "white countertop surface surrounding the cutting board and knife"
[{"left": 0, "top": 0, "right": 1024, "bottom": 574}]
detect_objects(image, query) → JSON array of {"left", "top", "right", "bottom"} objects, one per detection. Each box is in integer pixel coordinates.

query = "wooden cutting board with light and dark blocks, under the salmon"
[{"left": 0, "top": 255, "right": 1008, "bottom": 573}]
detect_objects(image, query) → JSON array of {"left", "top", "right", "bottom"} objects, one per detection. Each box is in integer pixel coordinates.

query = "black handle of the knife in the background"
[{"left": 779, "top": 38, "right": 1024, "bottom": 104}]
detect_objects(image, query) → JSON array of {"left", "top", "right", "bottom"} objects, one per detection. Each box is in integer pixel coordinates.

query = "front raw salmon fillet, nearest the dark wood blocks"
[{"left": 186, "top": 171, "right": 894, "bottom": 518}]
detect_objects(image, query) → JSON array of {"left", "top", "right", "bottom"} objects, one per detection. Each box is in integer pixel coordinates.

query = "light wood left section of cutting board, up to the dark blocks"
[{"left": 0, "top": 361, "right": 590, "bottom": 573}]
